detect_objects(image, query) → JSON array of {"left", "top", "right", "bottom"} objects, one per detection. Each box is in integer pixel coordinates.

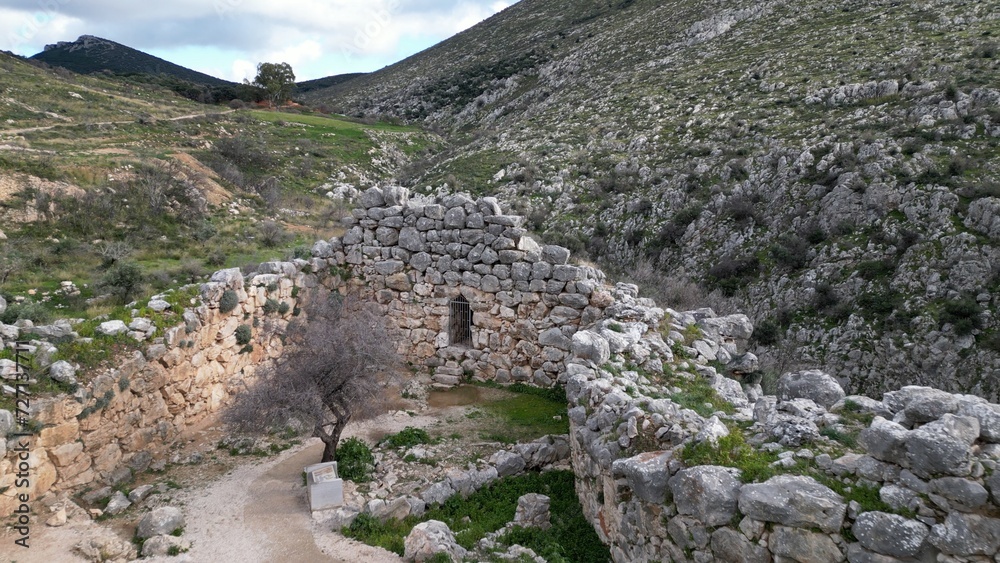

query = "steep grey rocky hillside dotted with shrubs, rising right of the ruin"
[{"left": 309, "top": 0, "right": 1000, "bottom": 400}]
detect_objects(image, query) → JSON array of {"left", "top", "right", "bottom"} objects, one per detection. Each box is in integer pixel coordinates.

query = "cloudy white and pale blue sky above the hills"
[{"left": 0, "top": 0, "right": 516, "bottom": 81}]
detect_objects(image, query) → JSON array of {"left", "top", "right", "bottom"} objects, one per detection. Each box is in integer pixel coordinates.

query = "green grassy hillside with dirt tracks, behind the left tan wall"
[{"left": 0, "top": 53, "right": 439, "bottom": 338}]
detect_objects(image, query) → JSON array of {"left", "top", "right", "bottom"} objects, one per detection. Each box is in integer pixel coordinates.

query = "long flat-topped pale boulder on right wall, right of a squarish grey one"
[{"left": 739, "top": 475, "right": 847, "bottom": 534}]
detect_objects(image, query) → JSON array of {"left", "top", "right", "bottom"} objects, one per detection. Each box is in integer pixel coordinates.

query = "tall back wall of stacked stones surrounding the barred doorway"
[{"left": 313, "top": 187, "right": 614, "bottom": 387}]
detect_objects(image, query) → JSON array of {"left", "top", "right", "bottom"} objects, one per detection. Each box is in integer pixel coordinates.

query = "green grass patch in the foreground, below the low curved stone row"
[{"left": 344, "top": 471, "right": 610, "bottom": 563}]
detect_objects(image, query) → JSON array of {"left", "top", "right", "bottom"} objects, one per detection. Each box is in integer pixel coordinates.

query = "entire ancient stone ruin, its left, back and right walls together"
[{"left": 0, "top": 187, "right": 1000, "bottom": 562}]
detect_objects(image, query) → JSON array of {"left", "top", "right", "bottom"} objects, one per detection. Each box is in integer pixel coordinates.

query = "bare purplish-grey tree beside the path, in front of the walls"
[{"left": 223, "top": 293, "right": 401, "bottom": 462}]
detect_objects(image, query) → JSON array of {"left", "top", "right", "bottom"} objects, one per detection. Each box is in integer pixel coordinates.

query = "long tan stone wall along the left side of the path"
[{"left": 0, "top": 261, "right": 317, "bottom": 516}]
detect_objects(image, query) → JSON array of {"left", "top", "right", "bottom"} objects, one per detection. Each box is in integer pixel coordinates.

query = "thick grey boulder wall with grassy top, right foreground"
[{"left": 566, "top": 293, "right": 1000, "bottom": 563}]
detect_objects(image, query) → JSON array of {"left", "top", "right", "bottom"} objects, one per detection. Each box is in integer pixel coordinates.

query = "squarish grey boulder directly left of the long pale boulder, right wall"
[{"left": 670, "top": 465, "right": 741, "bottom": 526}]
